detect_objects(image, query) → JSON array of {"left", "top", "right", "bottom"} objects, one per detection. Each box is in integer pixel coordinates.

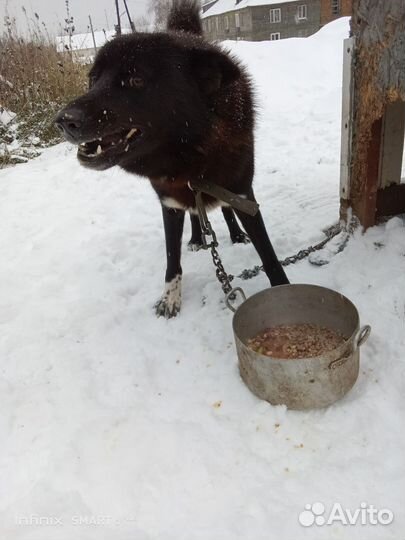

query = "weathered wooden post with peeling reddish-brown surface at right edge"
[{"left": 341, "top": 0, "right": 405, "bottom": 227}]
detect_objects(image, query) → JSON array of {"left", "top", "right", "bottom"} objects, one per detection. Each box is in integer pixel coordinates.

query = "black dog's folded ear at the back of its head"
[{"left": 191, "top": 48, "right": 241, "bottom": 94}]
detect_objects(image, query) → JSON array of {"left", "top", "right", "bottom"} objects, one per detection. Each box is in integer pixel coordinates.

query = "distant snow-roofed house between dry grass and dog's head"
[{"left": 56, "top": 28, "right": 131, "bottom": 64}]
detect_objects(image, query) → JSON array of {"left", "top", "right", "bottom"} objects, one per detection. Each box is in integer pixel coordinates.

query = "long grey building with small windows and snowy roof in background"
[{"left": 202, "top": 0, "right": 352, "bottom": 41}]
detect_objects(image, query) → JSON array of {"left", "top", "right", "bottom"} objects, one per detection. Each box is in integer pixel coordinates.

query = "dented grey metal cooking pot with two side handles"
[{"left": 226, "top": 284, "right": 371, "bottom": 410}]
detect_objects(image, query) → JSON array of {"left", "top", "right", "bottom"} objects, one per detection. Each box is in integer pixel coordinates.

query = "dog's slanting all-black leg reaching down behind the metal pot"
[{"left": 236, "top": 191, "right": 289, "bottom": 286}]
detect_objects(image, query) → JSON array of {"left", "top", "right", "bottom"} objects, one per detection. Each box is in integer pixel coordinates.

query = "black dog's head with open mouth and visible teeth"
[{"left": 56, "top": 33, "right": 241, "bottom": 170}]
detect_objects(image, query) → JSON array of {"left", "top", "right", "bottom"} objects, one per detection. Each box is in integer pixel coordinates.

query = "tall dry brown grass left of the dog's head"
[{"left": 0, "top": 12, "right": 88, "bottom": 148}]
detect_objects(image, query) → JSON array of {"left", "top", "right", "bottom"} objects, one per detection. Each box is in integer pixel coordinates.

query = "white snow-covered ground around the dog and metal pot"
[{"left": 0, "top": 20, "right": 405, "bottom": 540}]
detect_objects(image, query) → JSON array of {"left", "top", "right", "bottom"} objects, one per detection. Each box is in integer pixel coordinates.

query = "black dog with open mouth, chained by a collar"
[{"left": 56, "top": 0, "right": 288, "bottom": 317}]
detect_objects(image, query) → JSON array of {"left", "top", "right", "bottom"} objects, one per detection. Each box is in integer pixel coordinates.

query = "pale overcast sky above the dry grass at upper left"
[{"left": 0, "top": 0, "right": 148, "bottom": 35}]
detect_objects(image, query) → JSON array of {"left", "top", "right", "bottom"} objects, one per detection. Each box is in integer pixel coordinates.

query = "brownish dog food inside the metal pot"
[{"left": 248, "top": 324, "right": 345, "bottom": 359}]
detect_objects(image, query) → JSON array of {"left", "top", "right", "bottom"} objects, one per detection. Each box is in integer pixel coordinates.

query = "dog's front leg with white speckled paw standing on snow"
[{"left": 155, "top": 205, "right": 185, "bottom": 319}]
